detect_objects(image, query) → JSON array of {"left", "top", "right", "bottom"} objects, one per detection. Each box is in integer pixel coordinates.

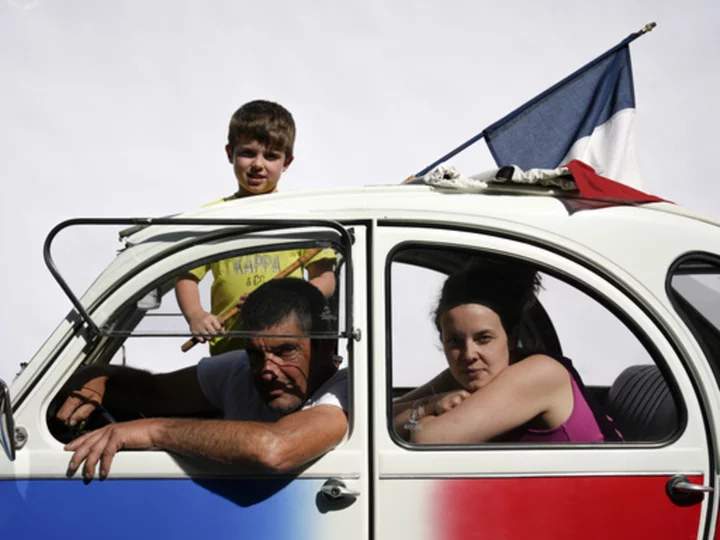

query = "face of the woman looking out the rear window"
[{"left": 440, "top": 304, "right": 510, "bottom": 392}]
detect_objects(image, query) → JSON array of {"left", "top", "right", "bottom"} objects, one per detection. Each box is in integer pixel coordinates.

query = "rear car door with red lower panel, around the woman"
[{"left": 372, "top": 222, "right": 715, "bottom": 540}]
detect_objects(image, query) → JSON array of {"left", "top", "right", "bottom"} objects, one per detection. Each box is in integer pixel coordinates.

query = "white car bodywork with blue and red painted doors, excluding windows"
[{"left": 0, "top": 186, "right": 720, "bottom": 539}]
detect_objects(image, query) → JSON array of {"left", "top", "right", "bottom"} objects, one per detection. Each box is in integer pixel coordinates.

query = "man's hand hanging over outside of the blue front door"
[{"left": 65, "top": 419, "right": 160, "bottom": 481}]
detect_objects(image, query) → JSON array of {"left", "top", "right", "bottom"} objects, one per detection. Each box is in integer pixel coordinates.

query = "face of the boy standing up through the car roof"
[{"left": 225, "top": 141, "right": 292, "bottom": 196}]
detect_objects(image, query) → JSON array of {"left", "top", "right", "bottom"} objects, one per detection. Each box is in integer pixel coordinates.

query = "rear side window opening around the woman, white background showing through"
[{"left": 388, "top": 246, "right": 682, "bottom": 442}]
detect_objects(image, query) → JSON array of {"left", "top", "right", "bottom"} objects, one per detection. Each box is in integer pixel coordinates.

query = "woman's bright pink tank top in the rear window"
[{"left": 496, "top": 373, "right": 605, "bottom": 443}]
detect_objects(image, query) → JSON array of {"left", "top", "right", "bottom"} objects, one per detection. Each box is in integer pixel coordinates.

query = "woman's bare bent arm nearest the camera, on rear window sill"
[{"left": 410, "top": 355, "right": 573, "bottom": 444}]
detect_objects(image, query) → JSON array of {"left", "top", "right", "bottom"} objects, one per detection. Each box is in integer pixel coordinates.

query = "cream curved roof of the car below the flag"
[{"left": 108, "top": 185, "right": 720, "bottom": 296}]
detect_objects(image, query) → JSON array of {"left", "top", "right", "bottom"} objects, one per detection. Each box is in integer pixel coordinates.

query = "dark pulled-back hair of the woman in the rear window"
[{"left": 435, "top": 260, "right": 540, "bottom": 339}]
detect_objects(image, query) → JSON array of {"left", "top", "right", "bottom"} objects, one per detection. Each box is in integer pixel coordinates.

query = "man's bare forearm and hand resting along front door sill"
[{"left": 65, "top": 405, "right": 348, "bottom": 480}]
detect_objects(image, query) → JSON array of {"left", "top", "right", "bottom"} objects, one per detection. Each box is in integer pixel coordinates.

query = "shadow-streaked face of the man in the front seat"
[{"left": 246, "top": 315, "right": 311, "bottom": 414}]
